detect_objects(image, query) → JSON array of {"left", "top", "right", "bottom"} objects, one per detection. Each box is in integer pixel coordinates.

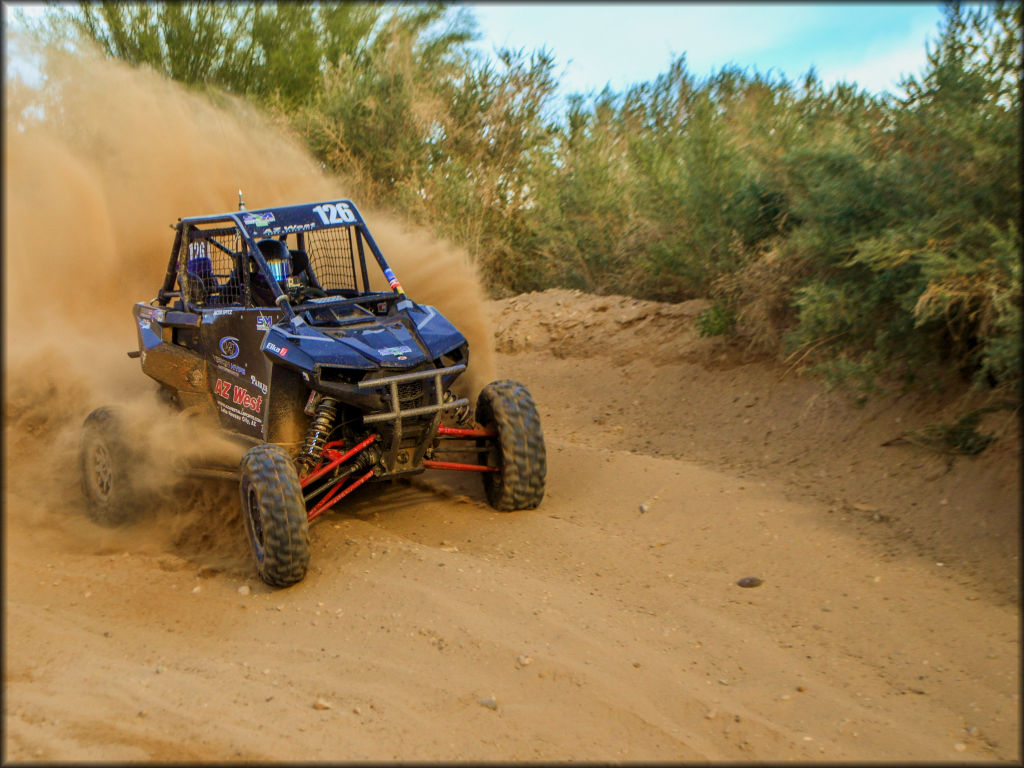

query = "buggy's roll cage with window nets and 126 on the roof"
[{"left": 155, "top": 200, "right": 404, "bottom": 317}]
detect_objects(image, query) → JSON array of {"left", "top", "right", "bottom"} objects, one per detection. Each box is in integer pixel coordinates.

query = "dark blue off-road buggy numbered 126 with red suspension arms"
[{"left": 81, "top": 200, "right": 546, "bottom": 587}]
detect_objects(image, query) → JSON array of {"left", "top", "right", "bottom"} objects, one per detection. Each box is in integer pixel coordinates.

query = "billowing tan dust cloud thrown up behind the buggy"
[{"left": 3, "top": 41, "right": 494, "bottom": 548}]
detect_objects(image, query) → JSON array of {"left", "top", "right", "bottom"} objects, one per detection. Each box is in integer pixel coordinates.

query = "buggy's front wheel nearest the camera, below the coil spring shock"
[{"left": 240, "top": 443, "right": 309, "bottom": 587}]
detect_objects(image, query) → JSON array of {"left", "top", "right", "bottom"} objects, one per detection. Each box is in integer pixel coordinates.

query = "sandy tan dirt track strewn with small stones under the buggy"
[{"left": 4, "top": 292, "right": 1020, "bottom": 762}]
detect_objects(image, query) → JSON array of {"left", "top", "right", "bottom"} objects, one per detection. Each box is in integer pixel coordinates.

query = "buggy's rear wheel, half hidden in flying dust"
[{"left": 79, "top": 408, "right": 138, "bottom": 526}]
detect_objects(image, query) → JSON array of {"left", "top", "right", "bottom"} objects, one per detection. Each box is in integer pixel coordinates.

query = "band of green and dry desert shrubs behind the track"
[{"left": 19, "top": 2, "right": 1022, "bottom": 389}]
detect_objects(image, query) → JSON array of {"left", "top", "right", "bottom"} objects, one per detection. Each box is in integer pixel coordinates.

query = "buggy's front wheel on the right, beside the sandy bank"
[{"left": 476, "top": 379, "right": 548, "bottom": 511}]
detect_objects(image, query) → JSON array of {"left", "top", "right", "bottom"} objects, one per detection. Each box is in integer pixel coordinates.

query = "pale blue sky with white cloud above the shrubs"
[{"left": 461, "top": 2, "right": 942, "bottom": 97}]
